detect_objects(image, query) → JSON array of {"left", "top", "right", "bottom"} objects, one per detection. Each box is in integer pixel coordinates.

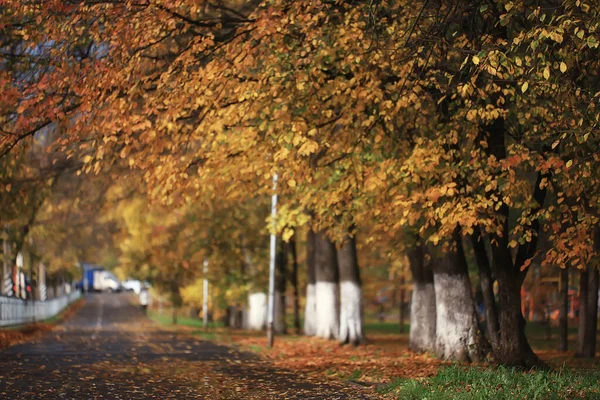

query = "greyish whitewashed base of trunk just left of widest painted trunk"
[{"left": 409, "top": 282, "right": 436, "bottom": 352}]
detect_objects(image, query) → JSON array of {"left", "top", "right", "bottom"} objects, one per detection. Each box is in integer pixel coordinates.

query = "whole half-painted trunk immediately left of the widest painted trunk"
[{"left": 407, "top": 241, "right": 436, "bottom": 352}]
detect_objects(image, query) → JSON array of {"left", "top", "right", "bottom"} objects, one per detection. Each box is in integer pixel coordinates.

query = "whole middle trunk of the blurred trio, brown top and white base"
[{"left": 315, "top": 231, "right": 340, "bottom": 339}]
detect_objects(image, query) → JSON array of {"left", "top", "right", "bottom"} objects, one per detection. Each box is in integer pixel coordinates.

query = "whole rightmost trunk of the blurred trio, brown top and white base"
[{"left": 337, "top": 233, "right": 363, "bottom": 345}]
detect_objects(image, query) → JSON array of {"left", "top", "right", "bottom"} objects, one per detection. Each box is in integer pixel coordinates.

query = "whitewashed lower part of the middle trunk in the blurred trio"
[{"left": 315, "top": 281, "right": 340, "bottom": 339}]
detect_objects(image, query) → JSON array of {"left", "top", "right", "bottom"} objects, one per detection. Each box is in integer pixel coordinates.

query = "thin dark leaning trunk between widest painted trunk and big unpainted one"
[{"left": 471, "top": 227, "right": 500, "bottom": 347}]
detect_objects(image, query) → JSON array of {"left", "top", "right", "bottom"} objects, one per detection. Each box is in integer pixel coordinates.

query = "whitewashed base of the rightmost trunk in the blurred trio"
[{"left": 339, "top": 281, "right": 363, "bottom": 344}]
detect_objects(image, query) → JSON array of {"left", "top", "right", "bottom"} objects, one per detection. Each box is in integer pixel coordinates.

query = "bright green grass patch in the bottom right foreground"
[{"left": 379, "top": 366, "right": 600, "bottom": 400}]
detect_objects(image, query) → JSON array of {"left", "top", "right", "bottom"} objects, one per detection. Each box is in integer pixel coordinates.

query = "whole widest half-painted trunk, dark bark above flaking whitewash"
[{"left": 432, "top": 231, "right": 485, "bottom": 361}]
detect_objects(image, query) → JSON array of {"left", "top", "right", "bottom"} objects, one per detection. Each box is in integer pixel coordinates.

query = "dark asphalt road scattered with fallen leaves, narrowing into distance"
[{"left": 0, "top": 294, "right": 369, "bottom": 400}]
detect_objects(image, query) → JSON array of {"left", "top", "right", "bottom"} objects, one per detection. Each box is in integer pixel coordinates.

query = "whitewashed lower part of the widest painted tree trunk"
[{"left": 433, "top": 273, "right": 480, "bottom": 361}]
